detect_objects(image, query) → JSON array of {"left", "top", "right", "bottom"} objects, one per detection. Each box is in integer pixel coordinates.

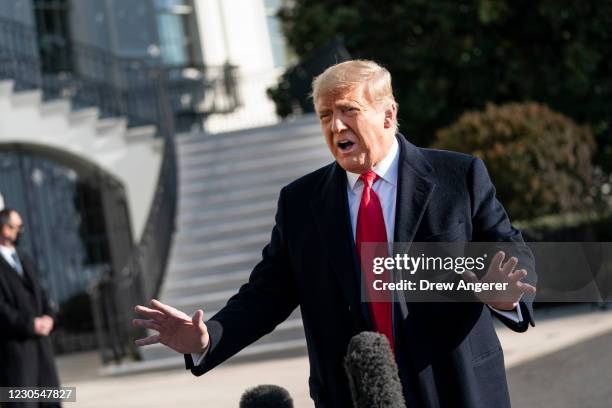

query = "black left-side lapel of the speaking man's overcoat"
[{"left": 311, "top": 163, "right": 364, "bottom": 322}]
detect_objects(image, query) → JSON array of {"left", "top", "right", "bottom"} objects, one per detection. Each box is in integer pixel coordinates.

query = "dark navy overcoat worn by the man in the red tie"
[{"left": 186, "top": 135, "right": 534, "bottom": 408}]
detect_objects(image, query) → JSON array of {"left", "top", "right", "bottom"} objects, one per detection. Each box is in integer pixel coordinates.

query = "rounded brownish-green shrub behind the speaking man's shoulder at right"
[{"left": 435, "top": 103, "right": 595, "bottom": 219}]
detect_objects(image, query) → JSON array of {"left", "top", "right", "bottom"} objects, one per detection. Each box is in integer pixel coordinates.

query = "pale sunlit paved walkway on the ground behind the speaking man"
[{"left": 58, "top": 305, "right": 612, "bottom": 408}]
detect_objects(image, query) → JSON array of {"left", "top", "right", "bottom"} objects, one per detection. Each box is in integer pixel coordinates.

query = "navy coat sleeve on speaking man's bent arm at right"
[{"left": 468, "top": 157, "right": 537, "bottom": 332}]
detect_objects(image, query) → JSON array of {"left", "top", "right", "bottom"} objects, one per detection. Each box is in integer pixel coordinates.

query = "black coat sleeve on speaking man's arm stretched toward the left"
[{"left": 185, "top": 186, "right": 298, "bottom": 376}]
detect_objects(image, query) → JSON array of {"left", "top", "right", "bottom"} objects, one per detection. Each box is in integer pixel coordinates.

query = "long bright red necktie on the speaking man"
[{"left": 356, "top": 171, "right": 394, "bottom": 350}]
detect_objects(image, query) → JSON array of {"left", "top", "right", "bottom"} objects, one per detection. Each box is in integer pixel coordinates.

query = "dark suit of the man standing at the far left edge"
[{"left": 0, "top": 253, "right": 59, "bottom": 408}]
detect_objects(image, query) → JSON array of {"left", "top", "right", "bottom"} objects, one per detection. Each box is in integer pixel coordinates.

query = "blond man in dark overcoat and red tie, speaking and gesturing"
[{"left": 134, "top": 60, "right": 535, "bottom": 407}]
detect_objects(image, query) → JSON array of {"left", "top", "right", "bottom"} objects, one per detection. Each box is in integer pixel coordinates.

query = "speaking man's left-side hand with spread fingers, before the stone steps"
[{"left": 132, "top": 299, "right": 209, "bottom": 354}]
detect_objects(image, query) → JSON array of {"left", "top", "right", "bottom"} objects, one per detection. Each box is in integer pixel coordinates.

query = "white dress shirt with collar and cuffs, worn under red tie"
[{"left": 191, "top": 139, "right": 523, "bottom": 365}]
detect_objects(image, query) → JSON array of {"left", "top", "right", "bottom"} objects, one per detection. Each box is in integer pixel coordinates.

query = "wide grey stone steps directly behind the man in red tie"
[{"left": 142, "top": 116, "right": 333, "bottom": 368}]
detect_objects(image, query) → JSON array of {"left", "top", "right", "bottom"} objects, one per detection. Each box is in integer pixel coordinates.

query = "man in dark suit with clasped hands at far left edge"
[{"left": 0, "top": 209, "right": 60, "bottom": 407}]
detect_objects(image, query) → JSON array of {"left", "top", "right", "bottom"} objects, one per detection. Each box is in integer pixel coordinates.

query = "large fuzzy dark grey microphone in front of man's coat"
[{"left": 344, "top": 332, "right": 406, "bottom": 408}]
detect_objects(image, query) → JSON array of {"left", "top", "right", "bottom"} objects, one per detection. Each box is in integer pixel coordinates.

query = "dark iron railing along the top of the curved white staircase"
[{"left": 0, "top": 18, "right": 240, "bottom": 134}]
